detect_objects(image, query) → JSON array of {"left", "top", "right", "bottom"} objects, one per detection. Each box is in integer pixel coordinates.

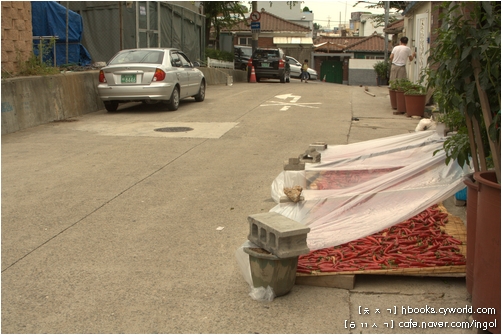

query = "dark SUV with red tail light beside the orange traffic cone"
[{"left": 248, "top": 48, "right": 290, "bottom": 83}]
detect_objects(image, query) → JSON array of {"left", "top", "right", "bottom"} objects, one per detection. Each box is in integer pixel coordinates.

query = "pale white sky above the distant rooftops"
[{"left": 301, "top": 0, "right": 384, "bottom": 28}]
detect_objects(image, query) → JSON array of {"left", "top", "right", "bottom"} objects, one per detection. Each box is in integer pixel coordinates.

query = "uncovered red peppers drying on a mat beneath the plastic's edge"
[{"left": 297, "top": 205, "right": 466, "bottom": 273}]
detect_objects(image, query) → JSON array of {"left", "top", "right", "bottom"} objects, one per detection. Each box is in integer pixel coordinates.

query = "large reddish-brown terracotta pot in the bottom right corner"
[{"left": 472, "top": 171, "right": 500, "bottom": 334}]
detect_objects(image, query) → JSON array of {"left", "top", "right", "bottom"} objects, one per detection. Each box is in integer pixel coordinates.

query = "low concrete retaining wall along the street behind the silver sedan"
[{"left": 2, "top": 67, "right": 247, "bottom": 135}]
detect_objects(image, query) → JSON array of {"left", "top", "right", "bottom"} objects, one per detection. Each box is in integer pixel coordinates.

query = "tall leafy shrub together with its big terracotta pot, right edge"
[{"left": 428, "top": 2, "right": 501, "bottom": 333}]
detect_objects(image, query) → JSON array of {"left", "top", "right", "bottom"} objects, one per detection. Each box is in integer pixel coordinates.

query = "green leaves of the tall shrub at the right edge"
[{"left": 427, "top": 1, "right": 501, "bottom": 172}]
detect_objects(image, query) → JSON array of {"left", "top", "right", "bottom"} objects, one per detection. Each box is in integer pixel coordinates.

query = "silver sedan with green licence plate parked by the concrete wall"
[{"left": 98, "top": 48, "right": 206, "bottom": 112}]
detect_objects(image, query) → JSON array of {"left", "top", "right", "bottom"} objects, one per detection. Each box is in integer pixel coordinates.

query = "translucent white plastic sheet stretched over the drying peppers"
[{"left": 270, "top": 130, "right": 472, "bottom": 250}]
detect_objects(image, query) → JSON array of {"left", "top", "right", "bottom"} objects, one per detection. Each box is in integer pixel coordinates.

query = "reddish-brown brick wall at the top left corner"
[{"left": 1, "top": 1, "right": 33, "bottom": 73}]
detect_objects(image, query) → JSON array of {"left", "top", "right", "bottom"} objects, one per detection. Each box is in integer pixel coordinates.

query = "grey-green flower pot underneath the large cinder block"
[{"left": 244, "top": 247, "right": 298, "bottom": 297}]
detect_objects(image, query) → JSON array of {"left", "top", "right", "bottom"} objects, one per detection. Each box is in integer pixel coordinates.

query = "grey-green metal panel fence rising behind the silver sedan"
[{"left": 64, "top": 1, "right": 205, "bottom": 62}]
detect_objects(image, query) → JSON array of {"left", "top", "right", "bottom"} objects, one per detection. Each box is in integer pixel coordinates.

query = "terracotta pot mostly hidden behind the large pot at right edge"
[{"left": 464, "top": 173, "right": 479, "bottom": 295}]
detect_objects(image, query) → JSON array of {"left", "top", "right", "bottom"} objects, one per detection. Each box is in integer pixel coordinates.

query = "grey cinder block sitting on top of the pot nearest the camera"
[{"left": 248, "top": 212, "right": 310, "bottom": 258}]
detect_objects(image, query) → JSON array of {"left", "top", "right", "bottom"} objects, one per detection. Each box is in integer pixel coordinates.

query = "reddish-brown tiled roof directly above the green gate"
[{"left": 314, "top": 34, "right": 392, "bottom": 52}]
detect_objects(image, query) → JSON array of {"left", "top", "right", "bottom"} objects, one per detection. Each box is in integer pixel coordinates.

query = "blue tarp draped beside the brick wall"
[{"left": 31, "top": 1, "right": 91, "bottom": 66}]
